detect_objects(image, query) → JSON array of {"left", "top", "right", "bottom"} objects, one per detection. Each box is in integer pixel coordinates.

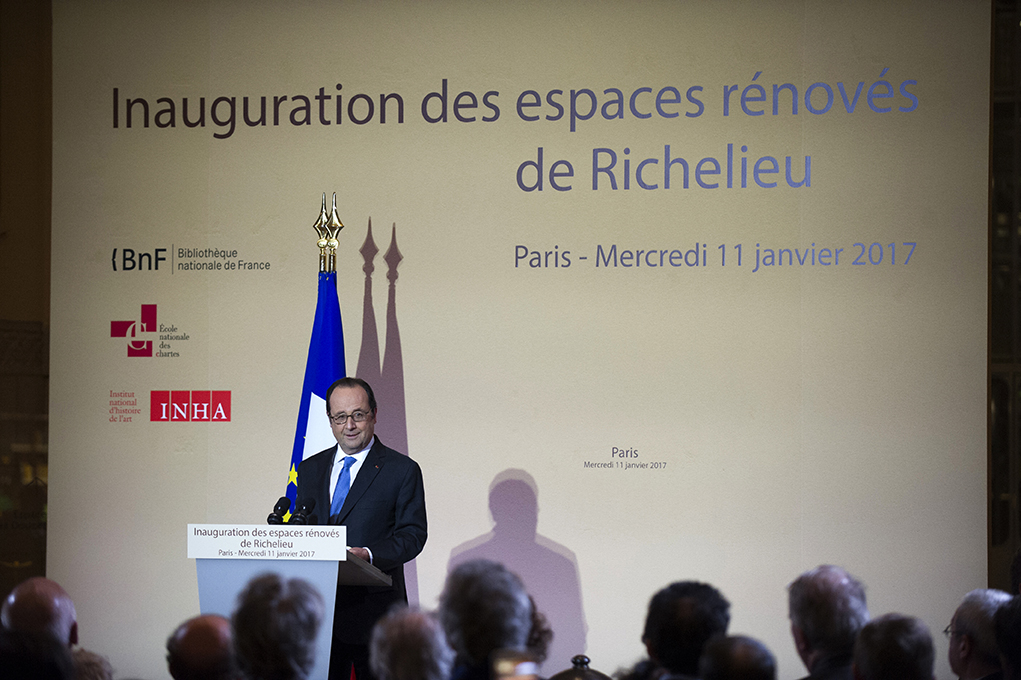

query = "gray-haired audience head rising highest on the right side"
[{"left": 787, "top": 565, "right": 869, "bottom": 655}]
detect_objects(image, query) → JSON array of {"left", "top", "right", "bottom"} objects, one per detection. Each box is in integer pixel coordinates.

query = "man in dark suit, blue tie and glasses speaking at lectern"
[{"left": 298, "top": 378, "right": 427, "bottom": 680}]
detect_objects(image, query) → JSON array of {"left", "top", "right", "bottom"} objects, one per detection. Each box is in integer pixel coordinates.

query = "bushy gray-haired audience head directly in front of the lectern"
[{"left": 231, "top": 574, "right": 326, "bottom": 680}]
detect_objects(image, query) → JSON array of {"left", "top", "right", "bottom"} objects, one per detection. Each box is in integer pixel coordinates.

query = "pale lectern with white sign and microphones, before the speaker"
[{"left": 188, "top": 524, "right": 392, "bottom": 680}]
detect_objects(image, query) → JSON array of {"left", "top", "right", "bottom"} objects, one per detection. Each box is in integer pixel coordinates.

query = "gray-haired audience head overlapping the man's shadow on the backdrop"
[{"left": 439, "top": 560, "right": 532, "bottom": 666}]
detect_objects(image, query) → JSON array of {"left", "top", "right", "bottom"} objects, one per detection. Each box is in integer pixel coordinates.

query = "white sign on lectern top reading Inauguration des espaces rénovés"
[{"left": 188, "top": 524, "right": 347, "bottom": 562}]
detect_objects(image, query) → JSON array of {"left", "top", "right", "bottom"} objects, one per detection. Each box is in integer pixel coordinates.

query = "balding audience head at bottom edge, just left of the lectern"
[{"left": 166, "top": 614, "right": 234, "bottom": 680}]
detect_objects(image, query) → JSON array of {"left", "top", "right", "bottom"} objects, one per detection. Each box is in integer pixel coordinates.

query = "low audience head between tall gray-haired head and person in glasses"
[{"left": 855, "top": 614, "right": 935, "bottom": 680}]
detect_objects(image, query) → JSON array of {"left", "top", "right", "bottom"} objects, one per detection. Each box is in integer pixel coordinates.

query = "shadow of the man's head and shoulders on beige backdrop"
[{"left": 447, "top": 470, "right": 587, "bottom": 676}]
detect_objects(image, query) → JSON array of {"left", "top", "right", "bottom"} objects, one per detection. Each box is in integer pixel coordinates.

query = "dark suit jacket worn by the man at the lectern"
[{"left": 298, "top": 437, "right": 427, "bottom": 644}]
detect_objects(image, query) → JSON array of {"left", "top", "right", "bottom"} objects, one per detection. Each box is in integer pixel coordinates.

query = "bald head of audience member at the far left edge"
[{"left": 0, "top": 576, "right": 78, "bottom": 646}]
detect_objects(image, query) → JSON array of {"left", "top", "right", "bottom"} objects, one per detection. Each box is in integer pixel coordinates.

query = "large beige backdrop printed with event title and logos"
[{"left": 47, "top": 0, "right": 989, "bottom": 678}]
